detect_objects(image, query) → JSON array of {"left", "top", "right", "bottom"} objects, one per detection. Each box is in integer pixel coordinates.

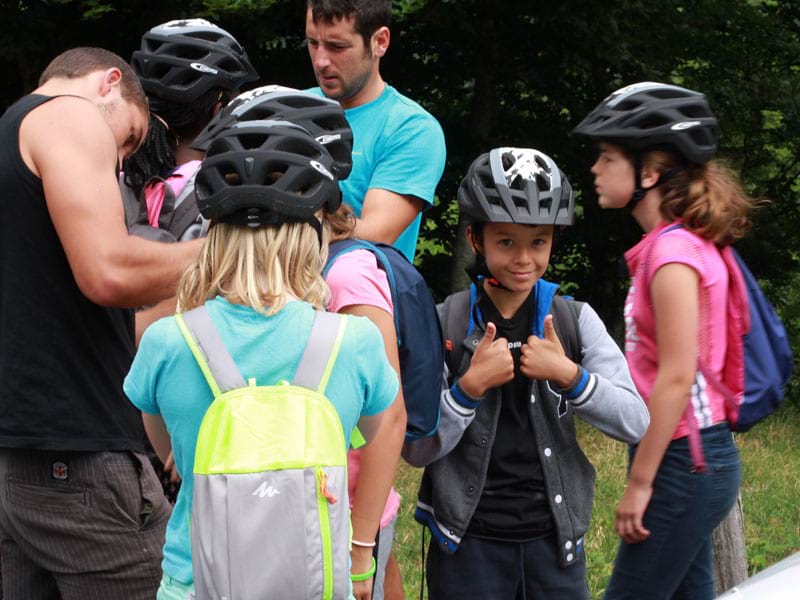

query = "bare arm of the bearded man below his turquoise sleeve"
[{"left": 355, "top": 188, "right": 425, "bottom": 244}]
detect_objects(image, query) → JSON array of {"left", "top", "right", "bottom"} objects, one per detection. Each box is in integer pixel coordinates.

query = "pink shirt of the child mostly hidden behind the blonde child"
[{"left": 326, "top": 250, "right": 400, "bottom": 529}]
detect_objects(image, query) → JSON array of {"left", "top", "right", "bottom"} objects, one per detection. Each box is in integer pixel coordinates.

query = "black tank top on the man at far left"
[{"left": 0, "top": 95, "right": 143, "bottom": 451}]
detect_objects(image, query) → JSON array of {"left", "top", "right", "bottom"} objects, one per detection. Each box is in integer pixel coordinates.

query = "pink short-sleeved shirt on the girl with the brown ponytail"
[{"left": 625, "top": 223, "right": 728, "bottom": 439}]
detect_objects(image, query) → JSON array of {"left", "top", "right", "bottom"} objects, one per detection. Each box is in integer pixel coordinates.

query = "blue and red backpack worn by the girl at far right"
[{"left": 648, "top": 223, "right": 793, "bottom": 470}]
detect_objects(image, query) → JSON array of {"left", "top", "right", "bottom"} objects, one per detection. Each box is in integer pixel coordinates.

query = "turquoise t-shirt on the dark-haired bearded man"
[{"left": 309, "top": 85, "right": 446, "bottom": 262}]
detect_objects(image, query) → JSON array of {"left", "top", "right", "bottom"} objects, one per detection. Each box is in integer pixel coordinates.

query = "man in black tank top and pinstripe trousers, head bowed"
[{"left": 0, "top": 48, "right": 199, "bottom": 600}]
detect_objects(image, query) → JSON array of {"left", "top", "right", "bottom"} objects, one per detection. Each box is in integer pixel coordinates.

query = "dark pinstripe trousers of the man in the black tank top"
[{"left": 0, "top": 449, "right": 171, "bottom": 600}]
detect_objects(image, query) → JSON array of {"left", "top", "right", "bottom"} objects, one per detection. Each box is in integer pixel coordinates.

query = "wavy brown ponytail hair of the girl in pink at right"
[{"left": 642, "top": 150, "right": 758, "bottom": 246}]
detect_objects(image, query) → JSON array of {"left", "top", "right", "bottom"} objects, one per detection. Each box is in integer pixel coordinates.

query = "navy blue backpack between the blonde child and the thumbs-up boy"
[{"left": 323, "top": 239, "right": 444, "bottom": 441}]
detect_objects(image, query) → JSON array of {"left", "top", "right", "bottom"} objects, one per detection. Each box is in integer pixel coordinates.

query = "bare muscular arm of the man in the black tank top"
[{"left": 20, "top": 97, "right": 202, "bottom": 306}]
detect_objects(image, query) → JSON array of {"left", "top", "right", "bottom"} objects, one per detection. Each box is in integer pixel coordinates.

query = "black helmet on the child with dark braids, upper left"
[{"left": 131, "top": 19, "right": 258, "bottom": 104}]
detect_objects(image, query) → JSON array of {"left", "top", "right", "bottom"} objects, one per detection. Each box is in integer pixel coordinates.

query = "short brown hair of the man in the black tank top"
[{"left": 39, "top": 46, "right": 148, "bottom": 113}]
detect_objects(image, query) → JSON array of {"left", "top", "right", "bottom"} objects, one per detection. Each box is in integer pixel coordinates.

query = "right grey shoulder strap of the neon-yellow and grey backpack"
[{"left": 292, "top": 310, "right": 347, "bottom": 394}]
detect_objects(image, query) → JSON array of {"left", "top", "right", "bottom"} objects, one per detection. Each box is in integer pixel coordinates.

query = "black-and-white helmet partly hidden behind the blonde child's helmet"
[{"left": 192, "top": 85, "right": 353, "bottom": 179}]
